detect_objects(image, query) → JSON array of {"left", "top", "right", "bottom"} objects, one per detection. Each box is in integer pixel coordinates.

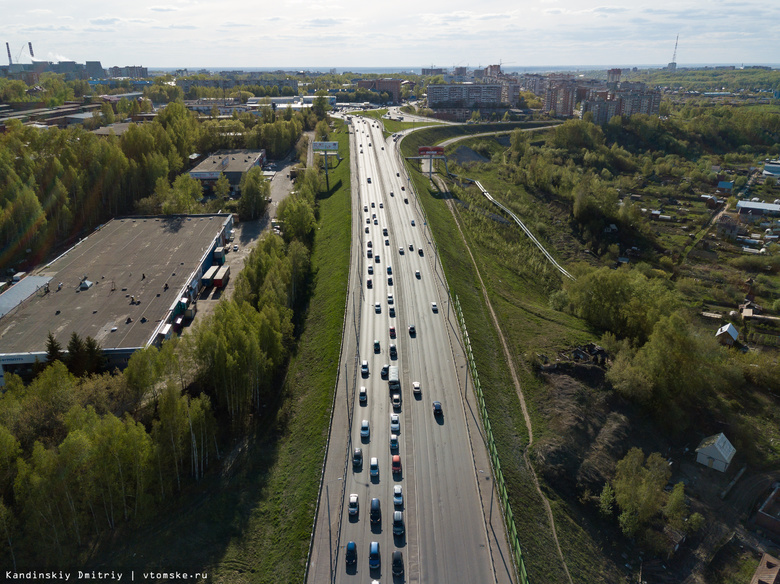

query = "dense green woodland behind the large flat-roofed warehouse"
[{"left": 0, "top": 103, "right": 318, "bottom": 270}]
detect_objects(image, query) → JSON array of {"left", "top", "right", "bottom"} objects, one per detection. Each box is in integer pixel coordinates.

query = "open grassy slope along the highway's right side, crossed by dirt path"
[{"left": 403, "top": 124, "right": 614, "bottom": 584}]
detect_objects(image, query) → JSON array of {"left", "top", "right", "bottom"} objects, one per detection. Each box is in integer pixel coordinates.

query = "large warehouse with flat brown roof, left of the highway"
[{"left": 0, "top": 214, "right": 233, "bottom": 386}]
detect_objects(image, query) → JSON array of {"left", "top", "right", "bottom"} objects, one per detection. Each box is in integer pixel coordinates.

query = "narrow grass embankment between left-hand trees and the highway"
[{"left": 87, "top": 121, "right": 351, "bottom": 584}]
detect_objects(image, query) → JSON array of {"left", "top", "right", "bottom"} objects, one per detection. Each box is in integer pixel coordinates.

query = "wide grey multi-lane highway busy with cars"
[{"left": 308, "top": 117, "right": 513, "bottom": 583}]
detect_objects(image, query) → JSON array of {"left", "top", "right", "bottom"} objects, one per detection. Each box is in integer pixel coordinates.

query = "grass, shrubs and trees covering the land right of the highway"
[{"left": 402, "top": 101, "right": 780, "bottom": 582}]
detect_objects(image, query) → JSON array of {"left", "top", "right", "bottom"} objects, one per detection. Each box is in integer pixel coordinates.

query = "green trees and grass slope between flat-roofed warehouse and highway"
[{"left": 0, "top": 106, "right": 350, "bottom": 582}]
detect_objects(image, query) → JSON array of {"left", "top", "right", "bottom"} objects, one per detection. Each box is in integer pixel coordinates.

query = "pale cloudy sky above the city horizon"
[{"left": 0, "top": 0, "right": 780, "bottom": 69}]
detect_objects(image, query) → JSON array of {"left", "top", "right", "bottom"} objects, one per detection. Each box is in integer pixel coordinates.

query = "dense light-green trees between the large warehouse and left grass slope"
[{"left": 0, "top": 169, "right": 322, "bottom": 569}]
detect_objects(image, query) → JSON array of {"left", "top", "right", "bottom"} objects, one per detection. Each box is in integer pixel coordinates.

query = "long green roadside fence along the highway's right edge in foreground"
[{"left": 455, "top": 295, "right": 530, "bottom": 584}]
